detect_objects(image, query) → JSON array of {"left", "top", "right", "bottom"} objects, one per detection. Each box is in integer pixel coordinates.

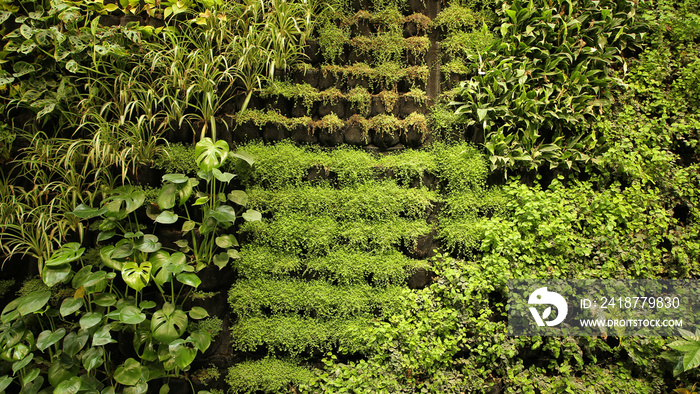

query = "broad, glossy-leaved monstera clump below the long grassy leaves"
[{"left": 0, "top": 138, "right": 261, "bottom": 394}]
